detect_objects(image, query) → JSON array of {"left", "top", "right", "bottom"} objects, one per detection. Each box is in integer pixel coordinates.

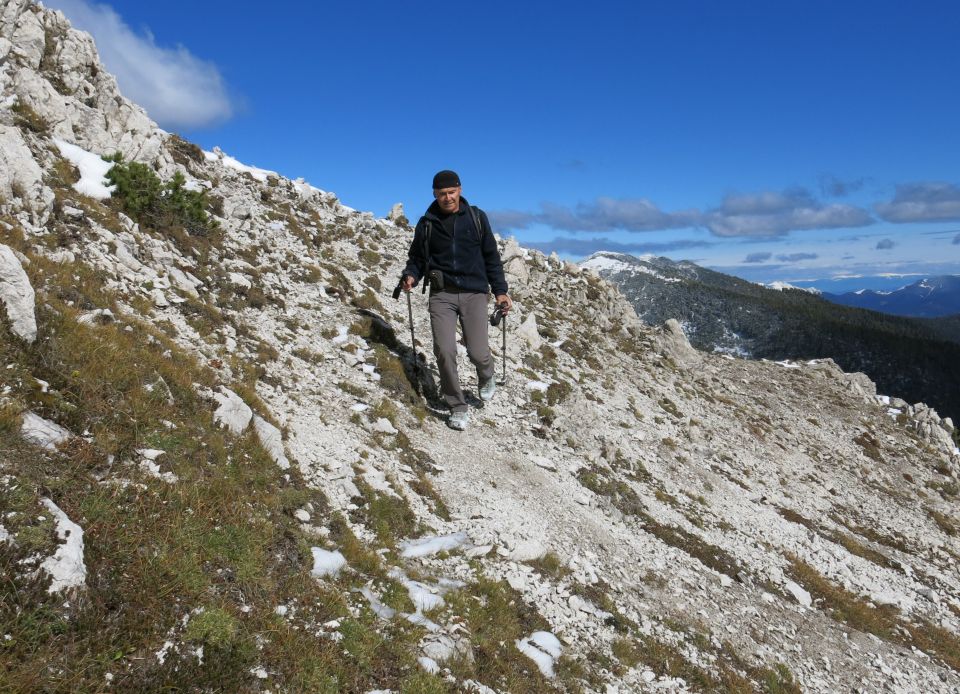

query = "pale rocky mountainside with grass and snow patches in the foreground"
[{"left": 0, "top": 0, "right": 960, "bottom": 694}]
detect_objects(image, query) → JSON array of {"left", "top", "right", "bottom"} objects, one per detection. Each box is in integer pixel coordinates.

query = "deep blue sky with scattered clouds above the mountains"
[{"left": 46, "top": 0, "right": 960, "bottom": 290}]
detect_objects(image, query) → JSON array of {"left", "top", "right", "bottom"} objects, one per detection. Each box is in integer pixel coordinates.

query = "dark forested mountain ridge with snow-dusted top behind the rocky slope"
[{"left": 581, "top": 252, "right": 960, "bottom": 418}]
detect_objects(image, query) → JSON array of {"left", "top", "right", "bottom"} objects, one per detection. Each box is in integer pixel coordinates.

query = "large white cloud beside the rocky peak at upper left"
[{"left": 46, "top": 0, "right": 234, "bottom": 129}]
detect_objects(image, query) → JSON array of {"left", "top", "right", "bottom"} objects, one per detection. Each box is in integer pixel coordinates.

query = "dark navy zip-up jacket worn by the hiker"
[{"left": 403, "top": 197, "right": 507, "bottom": 296}]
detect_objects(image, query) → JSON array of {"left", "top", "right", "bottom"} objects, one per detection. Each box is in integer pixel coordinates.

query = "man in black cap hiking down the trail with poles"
[{"left": 400, "top": 171, "right": 513, "bottom": 431}]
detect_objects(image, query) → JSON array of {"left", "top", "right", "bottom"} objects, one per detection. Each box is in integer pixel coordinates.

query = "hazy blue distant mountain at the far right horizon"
[{"left": 821, "top": 275, "right": 960, "bottom": 318}]
